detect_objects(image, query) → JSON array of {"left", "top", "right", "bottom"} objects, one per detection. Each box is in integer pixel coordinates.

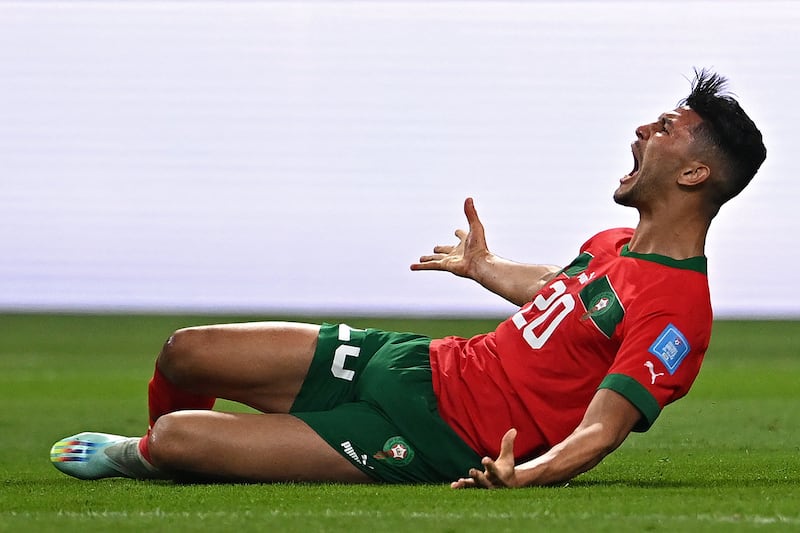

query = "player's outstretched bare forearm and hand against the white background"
[{"left": 411, "top": 198, "right": 560, "bottom": 306}]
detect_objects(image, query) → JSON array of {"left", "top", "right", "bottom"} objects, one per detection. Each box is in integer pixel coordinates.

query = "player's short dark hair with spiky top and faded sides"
[{"left": 679, "top": 69, "right": 767, "bottom": 206}]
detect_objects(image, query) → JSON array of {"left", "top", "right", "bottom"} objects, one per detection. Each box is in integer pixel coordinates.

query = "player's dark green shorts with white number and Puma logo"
[{"left": 290, "top": 324, "right": 481, "bottom": 483}]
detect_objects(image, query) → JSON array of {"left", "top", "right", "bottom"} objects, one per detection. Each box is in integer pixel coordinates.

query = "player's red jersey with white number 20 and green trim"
[{"left": 430, "top": 228, "right": 712, "bottom": 459}]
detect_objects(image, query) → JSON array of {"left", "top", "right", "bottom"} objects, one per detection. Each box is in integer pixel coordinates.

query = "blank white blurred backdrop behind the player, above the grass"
[{"left": 0, "top": 1, "right": 800, "bottom": 317}]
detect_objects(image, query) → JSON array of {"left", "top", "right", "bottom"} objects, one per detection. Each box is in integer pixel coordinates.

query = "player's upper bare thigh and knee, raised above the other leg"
[{"left": 157, "top": 322, "right": 319, "bottom": 413}]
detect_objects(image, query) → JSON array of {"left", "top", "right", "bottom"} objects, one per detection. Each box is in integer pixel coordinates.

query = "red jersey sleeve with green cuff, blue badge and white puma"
[{"left": 599, "top": 287, "right": 711, "bottom": 431}]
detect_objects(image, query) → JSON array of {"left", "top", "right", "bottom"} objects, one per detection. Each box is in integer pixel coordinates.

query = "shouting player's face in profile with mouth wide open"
[{"left": 614, "top": 107, "right": 702, "bottom": 207}]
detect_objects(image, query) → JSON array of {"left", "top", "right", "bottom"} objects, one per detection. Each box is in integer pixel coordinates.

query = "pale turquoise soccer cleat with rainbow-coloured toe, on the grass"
[{"left": 50, "top": 432, "right": 156, "bottom": 479}]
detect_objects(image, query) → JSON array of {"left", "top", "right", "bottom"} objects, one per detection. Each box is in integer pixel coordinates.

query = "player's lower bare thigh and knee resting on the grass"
[{"left": 150, "top": 411, "right": 372, "bottom": 483}]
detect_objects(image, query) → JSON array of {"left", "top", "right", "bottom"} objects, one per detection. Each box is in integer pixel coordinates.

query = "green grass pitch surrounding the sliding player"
[{"left": 0, "top": 315, "right": 800, "bottom": 532}]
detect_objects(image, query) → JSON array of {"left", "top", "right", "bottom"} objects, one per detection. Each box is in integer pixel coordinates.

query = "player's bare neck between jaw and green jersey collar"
[{"left": 628, "top": 210, "right": 711, "bottom": 259}]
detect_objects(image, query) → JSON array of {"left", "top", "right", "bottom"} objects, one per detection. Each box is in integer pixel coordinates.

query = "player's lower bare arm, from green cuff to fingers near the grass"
[{"left": 451, "top": 389, "right": 642, "bottom": 488}]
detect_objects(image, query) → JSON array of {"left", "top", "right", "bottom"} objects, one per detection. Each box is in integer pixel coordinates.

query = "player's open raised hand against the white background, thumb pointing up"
[{"left": 411, "top": 198, "right": 490, "bottom": 279}]
